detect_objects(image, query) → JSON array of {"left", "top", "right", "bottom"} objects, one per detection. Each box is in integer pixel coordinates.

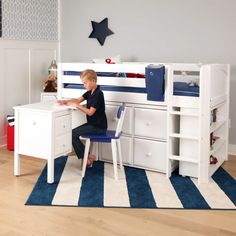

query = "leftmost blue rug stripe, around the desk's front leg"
[{"left": 25, "top": 156, "right": 67, "bottom": 206}]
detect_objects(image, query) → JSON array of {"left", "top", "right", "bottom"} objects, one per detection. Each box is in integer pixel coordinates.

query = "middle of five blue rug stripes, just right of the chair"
[{"left": 125, "top": 166, "right": 157, "bottom": 208}]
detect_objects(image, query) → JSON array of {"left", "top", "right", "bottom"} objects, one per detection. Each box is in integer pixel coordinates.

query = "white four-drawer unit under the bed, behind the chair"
[{"left": 99, "top": 101, "right": 171, "bottom": 173}]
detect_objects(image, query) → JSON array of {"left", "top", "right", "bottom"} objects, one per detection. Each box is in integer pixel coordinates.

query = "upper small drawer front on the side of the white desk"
[{"left": 55, "top": 115, "right": 71, "bottom": 136}]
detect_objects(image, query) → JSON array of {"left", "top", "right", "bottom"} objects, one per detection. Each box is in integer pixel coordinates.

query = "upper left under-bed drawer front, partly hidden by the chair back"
[{"left": 106, "top": 105, "right": 132, "bottom": 134}]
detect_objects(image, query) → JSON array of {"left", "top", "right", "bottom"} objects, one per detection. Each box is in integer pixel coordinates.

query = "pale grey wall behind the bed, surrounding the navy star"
[{"left": 60, "top": 0, "right": 236, "bottom": 148}]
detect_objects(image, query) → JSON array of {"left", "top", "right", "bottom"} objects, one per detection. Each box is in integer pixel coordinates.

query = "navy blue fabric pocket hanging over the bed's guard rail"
[{"left": 145, "top": 65, "right": 165, "bottom": 101}]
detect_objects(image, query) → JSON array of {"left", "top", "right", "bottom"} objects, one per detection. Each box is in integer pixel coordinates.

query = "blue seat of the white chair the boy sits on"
[{"left": 81, "top": 130, "right": 121, "bottom": 143}]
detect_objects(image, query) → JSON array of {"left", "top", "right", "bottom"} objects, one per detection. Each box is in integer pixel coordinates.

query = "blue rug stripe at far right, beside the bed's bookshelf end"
[{"left": 212, "top": 167, "right": 236, "bottom": 205}]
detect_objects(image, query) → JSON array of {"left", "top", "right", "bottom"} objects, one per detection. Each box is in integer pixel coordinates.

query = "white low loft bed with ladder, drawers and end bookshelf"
[{"left": 58, "top": 62, "right": 230, "bottom": 183}]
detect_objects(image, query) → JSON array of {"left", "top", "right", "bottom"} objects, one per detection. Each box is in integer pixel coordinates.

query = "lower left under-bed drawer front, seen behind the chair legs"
[{"left": 100, "top": 136, "right": 132, "bottom": 164}]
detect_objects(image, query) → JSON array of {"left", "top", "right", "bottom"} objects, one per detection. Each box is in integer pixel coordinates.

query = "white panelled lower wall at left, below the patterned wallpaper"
[{"left": 0, "top": 39, "right": 57, "bottom": 146}]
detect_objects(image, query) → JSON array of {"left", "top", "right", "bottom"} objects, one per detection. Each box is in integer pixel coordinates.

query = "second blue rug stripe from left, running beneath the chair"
[{"left": 78, "top": 161, "right": 104, "bottom": 207}]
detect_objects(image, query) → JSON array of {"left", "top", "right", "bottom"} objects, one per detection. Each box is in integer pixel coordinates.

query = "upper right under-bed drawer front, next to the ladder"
[{"left": 134, "top": 108, "right": 167, "bottom": 140}]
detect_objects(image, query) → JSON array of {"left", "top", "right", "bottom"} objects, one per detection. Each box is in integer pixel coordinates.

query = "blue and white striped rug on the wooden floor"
[{"left": 26, "top": 156, "right": 236, "bottom": 209}]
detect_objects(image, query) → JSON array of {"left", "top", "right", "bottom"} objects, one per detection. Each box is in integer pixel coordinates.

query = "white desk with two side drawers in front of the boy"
[{"left": 14, "top": 101, "right": 72, "bottom": 183}]
